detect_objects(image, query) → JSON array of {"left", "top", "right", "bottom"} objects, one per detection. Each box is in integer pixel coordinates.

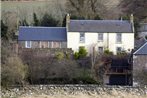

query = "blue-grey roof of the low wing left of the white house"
[{"left": 18, "top": 26, "right": 67, "bottom": 41}]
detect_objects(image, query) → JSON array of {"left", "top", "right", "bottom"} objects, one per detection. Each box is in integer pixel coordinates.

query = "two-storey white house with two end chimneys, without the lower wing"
[{"left": 66, "top": 15, "right": 134, "bottom": 54}]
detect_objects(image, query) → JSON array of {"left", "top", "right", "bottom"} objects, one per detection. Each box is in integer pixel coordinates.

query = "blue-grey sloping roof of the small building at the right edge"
[{"left": 134, "top": 42, "right": 147, "bottom": 55}]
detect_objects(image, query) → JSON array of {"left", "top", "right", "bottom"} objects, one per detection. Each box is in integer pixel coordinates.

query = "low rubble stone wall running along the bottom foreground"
[{"left": 1, "top": 85, "right": 147, "bottom": 98}]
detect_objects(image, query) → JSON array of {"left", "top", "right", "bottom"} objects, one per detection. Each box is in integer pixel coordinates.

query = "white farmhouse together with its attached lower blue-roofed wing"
[{"left": 18, "top": 15, "right": 134, "bottom": 54}]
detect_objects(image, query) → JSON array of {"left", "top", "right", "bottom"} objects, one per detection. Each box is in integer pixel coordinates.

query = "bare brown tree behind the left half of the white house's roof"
[{"left": 66, "top": 0, "right": 107, "bottom": 19}]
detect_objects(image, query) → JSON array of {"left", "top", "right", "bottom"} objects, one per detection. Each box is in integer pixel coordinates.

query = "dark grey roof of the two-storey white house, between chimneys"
[{"left": 68, "top": 20, "right": 132, "bottom": 33}]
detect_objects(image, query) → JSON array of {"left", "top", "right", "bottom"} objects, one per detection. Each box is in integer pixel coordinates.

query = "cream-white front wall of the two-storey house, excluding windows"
[{"left": 67, "top": 32, "right": 134, "bottom": 54}]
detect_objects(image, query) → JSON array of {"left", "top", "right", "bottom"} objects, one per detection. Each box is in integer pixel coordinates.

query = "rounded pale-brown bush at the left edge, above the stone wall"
[{"left": 1, "top": 56, "right": 27, "bottom": 86}]
